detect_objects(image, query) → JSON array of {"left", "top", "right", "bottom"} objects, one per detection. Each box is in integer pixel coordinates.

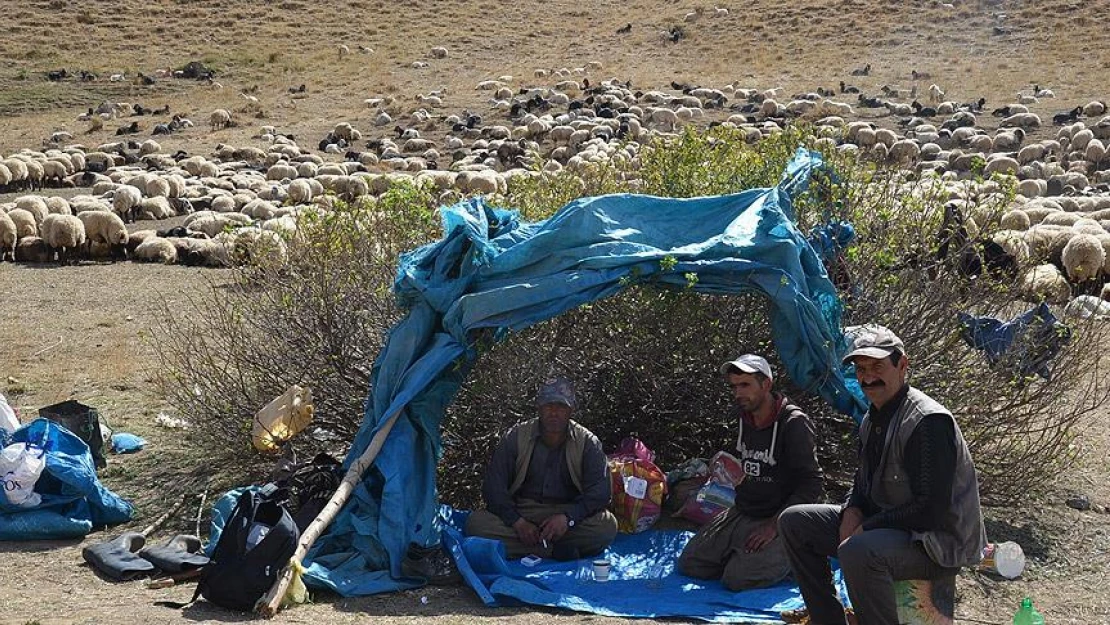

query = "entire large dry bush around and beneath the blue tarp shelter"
[{"left": 155, "top": 129, "right": 1110, "bottom": 506}]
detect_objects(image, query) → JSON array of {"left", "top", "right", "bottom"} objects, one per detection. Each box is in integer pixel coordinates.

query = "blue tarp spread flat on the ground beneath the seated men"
[{"left": 444, "top": 512, "right": 848, "bottom": 623}]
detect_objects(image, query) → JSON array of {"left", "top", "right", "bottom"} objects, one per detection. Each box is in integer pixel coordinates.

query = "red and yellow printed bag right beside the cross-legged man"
[{"left": 608, "top": 437, "right": 667, "bottom": 534}]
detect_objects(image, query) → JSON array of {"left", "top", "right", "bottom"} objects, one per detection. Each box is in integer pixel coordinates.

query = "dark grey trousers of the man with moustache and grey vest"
[{"left": 778, "top": 504, "right": 956, "bottom": 625}]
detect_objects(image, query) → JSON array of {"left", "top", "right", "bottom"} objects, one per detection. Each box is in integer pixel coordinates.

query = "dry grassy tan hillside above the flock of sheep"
[{"left": 0, "top": 0, "right": 1110, "bottom": 151}]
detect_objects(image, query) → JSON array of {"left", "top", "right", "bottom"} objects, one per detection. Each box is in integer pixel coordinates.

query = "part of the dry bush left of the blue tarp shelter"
[{"left": 154, "top": 185, "right": 438, "bottom": 470}]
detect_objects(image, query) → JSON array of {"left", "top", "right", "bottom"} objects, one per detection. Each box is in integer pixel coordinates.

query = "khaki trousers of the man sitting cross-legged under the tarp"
[{"left": 466, "top": 500, "right": 617, "bottom": 560}]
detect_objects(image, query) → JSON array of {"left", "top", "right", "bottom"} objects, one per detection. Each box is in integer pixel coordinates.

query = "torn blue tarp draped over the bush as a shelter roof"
[{"left": 307, "top": 150, "right": 866, "bottom": 596}]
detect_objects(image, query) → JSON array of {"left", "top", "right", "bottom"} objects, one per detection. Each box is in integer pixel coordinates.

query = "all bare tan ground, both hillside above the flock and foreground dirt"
[{"left": 0, "top": 0, "right": 1110, "bottom": 625}]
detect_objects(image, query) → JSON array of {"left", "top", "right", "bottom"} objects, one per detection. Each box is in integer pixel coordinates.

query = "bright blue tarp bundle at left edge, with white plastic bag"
[{"left": 0, "top": 419, "right": 132, "bottom": 541}]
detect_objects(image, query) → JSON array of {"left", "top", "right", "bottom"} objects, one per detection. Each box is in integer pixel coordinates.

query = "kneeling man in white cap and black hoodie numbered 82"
[{"left": 678, "top": 354, "right": 821, "bottom": 592}]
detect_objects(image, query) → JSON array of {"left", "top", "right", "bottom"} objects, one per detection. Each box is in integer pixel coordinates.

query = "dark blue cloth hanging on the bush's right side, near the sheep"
[{"left": 957, "top": 302, "right": 1071, "bottom": 380}]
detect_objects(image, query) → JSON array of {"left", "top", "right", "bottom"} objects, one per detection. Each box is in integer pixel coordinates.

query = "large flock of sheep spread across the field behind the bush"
[{"left": 0, "top": 59, "right": 1110, "bottom": 308}]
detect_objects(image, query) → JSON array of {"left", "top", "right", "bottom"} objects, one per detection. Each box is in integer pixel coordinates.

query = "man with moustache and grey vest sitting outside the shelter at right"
[{"left": 778, "top": 325, "right": 987, "bottom": 625}]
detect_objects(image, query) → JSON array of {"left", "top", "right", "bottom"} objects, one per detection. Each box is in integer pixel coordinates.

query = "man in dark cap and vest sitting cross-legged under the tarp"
[{"left": 466, "top": 377, "right": 617, "bottom": 560}]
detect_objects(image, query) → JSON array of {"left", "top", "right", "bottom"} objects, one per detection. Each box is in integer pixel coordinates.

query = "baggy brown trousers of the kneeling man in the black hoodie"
[{"left": 678, "top": 507, "right": 790, "bottom": 592}]
